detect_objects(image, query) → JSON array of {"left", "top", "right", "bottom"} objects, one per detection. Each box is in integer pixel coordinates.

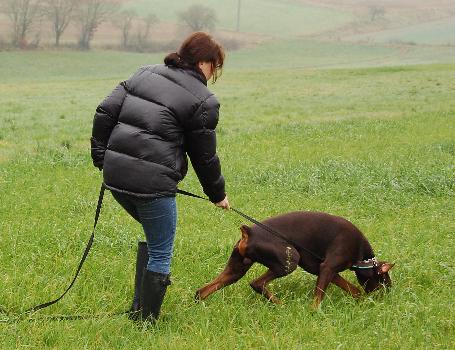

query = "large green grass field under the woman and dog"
[{"left": 0, "top": 45, "right": 455, "bottom": 349}]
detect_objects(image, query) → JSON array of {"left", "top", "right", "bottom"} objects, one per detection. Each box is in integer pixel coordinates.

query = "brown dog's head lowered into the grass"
[{"left": 354, "top": 261, "right": 395, "bottom": 293}]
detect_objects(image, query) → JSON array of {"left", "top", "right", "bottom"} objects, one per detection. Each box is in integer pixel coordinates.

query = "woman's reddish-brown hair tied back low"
[{"left": 164, "top": 32, "right": 224, "bottom": 83}]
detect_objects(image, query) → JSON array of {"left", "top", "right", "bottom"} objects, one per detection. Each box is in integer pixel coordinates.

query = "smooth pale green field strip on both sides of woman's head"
[{"left": 0, "top": 39, "right": 455, "bottom": 84}]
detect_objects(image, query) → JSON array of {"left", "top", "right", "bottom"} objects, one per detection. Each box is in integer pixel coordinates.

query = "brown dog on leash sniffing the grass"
[{"left": 196, "top": 212, "right": 394, "bottom": 307}]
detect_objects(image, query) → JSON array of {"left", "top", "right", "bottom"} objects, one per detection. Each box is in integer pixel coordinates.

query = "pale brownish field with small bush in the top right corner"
[{"left": 300, "top": 0, "right": 455, "bottom": 45}]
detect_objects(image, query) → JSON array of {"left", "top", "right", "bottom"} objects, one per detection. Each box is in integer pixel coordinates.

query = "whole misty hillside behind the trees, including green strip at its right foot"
[{"left": 0, "top": 0, "right": 455, "bottom": 67}]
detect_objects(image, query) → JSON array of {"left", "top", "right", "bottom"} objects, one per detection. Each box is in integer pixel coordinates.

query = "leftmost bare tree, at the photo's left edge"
[{"left": 0, "top": 0, "right": 42, "bottom": 47}]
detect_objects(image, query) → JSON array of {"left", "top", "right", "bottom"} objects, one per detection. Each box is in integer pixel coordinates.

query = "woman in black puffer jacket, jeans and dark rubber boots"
[{"left": 91, "top": 32, "right": 229, "bottom": 320}]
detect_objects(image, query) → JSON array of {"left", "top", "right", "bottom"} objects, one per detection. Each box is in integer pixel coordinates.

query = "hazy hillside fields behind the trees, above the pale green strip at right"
[{"left": 0, "top": 0, "right": 455, "bottom": 48}]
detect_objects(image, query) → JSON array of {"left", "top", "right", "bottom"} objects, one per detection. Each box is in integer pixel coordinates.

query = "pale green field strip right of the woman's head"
[{"left": 228, "top": 39, "right": 455, "bottom": 69}]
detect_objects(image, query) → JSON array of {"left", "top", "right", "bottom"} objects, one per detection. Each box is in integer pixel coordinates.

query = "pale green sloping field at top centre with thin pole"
[{"left": 126, "top": 0, "right": 353, "bottom": 37}]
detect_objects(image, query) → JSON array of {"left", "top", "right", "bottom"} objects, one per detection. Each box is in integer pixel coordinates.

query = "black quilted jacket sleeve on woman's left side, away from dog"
[{"left": 90, "top": 82, "right": 126, "bottom": 169}]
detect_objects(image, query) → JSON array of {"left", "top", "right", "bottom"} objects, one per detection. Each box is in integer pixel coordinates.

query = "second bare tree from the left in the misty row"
[{"left": 44, "top": 0, "right": 77, "bottom": 47}]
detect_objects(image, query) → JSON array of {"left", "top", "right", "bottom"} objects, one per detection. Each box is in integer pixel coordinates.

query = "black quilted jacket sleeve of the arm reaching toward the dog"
[{"left": 185, "top": 95, "right": 226, "bottom": 203}]
